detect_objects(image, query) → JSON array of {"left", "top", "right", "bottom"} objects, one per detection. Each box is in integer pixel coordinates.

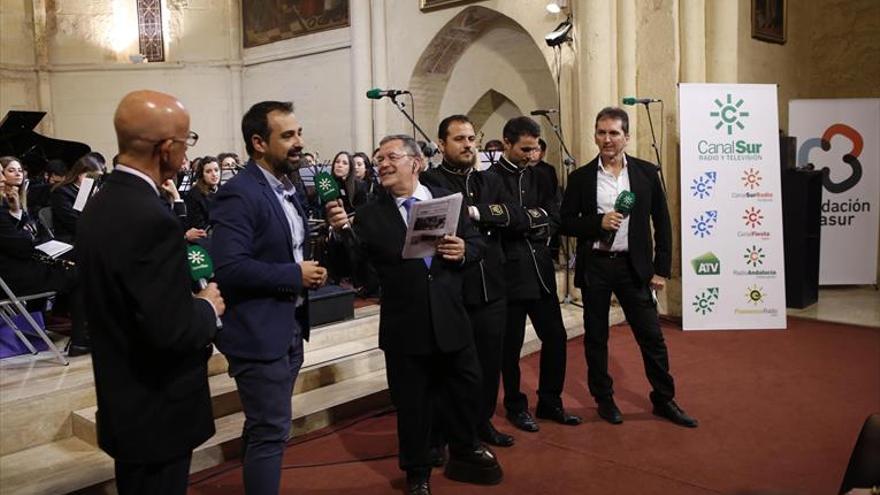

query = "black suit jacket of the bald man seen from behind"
[{"left": 76, "top": 171, "right": 216, "bottom": 463}]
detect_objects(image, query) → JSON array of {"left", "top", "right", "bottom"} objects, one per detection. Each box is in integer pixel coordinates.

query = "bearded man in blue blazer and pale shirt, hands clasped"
[{"left": 211, "top": 101, "right": 327, "bottom": 495}]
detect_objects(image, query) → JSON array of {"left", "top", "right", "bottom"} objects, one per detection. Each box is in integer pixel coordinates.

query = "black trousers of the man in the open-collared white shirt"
[{"left": 581, "top": 256, "right": 675, "bottom": 404}]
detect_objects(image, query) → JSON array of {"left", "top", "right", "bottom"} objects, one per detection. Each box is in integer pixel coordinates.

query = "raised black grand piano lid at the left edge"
[{"left": 0, "top": 110, "right": 92, "bottom": 176}]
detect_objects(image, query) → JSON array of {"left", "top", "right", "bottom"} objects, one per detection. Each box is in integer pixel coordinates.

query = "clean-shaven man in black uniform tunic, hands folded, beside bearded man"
[{"left": 481, "top": 117, "right": 581, "bottom": 432}]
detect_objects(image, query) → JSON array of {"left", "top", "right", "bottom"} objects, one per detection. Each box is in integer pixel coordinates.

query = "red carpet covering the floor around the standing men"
[{"left": 189, "top": 318, "right": 880, "bottom": 495}]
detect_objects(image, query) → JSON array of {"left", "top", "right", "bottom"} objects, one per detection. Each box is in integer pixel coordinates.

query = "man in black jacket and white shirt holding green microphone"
[{"left": 560, "top": 107, "right": 697, "bottom": 428}]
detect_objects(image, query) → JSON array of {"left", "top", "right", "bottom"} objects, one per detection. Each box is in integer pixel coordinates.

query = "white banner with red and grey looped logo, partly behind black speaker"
[{"left": 788, "top": 99, "right": 880, "bottom": 285}]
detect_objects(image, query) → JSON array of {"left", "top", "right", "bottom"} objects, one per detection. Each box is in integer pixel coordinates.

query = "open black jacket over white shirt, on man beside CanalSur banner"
[{"left": 560, "top": 155, "right": 672, "bottom": 287}]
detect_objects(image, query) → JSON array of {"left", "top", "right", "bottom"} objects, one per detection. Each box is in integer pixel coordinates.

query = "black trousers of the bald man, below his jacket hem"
[{"left": 114, "top": 452, "right": 192, "bottom": 495}]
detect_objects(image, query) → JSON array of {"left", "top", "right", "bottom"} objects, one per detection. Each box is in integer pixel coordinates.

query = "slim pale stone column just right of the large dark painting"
[{"left": 349, "top": 1, "right": 373, "bottom": 153}]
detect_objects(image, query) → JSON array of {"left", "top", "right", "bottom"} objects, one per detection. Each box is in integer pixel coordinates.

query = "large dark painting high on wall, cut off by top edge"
[{"left": 241, "top": 0, "right": 349, "bottom": 48}]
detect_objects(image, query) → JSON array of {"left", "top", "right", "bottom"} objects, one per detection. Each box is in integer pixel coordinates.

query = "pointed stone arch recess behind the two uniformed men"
[{"left": 408, "top": 5, "right": 557, "bottom": 157}]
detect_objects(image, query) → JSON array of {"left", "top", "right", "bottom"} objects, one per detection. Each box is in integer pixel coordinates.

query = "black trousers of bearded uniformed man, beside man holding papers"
[{"left": 467, "top": 298, "right": 507, "bottom": 425}]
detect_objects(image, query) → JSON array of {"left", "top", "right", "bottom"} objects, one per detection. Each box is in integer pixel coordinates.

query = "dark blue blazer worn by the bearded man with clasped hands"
[{"left": 211, "top": 160, "right": 309, "bottom": 360}]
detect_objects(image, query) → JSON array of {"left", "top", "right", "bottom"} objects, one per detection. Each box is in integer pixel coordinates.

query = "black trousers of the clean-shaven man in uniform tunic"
[{"left": 501, "top": 294, "right": 568, "bottom": 414}]
